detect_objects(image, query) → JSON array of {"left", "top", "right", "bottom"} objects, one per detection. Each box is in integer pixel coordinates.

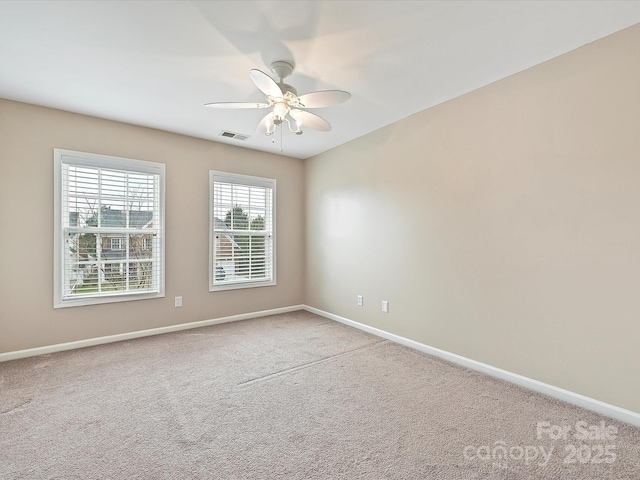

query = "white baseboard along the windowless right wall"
[{"left": 304, "top": 305, "right": 640, "bottom": 427}]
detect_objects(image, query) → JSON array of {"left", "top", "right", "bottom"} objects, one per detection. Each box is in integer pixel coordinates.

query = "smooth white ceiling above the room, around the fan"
[{"left": 0, "top": 0, "right": 640, "bottom": 158}]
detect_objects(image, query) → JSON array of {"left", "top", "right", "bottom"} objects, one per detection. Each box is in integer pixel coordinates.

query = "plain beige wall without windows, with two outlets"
[{"left": 306, "top": 26, "right": 640, "bottom": 412}]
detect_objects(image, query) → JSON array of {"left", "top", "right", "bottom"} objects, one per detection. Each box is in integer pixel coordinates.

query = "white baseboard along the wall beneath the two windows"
[{"left": 0, "top": 305, "right": 304, "bottom": 362}]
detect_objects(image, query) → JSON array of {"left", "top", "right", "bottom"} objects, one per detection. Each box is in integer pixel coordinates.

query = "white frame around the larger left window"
[{"left": 53, "top": 148, "right": 166, "bottom": 308}]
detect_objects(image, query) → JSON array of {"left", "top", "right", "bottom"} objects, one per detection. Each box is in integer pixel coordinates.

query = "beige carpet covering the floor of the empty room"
[{"left": 0, "top": 311, "right": 640, "bottom": 480}]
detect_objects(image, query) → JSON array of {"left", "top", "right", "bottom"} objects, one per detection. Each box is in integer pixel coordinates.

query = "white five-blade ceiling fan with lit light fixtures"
[{"left": 205, "top": 60, "right": 351, "bottom": 135}]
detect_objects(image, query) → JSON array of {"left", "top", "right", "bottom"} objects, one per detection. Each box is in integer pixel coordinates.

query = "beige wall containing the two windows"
[{"left": 0, "top": 100, "right": 304, "bottom": 353}]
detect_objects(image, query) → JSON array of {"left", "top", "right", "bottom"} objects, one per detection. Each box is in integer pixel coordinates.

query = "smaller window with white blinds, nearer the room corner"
[{"left": 209, "top": 170, "right": 276, "bottom": 291}]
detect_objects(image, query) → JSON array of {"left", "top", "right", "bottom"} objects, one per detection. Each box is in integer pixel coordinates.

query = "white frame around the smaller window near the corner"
[{"left": 209, "top": 170, "right": 277, "bottom": 292}]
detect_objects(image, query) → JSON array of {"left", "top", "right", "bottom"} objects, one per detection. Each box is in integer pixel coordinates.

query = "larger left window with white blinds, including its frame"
[{"left": 54, "top": 149, "right": 165, "bottom": 308}]
